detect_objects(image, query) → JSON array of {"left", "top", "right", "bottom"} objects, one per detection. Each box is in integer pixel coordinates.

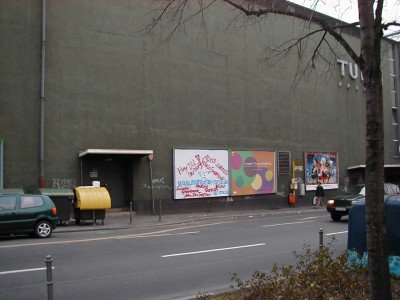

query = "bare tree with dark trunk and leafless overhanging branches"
[{"left": 148, "top": 0, "right": 399, "bottom": 299}]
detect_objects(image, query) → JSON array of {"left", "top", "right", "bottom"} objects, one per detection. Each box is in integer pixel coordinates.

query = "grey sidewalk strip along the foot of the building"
[{"left": 55, "top": 206, "right": 321, "bottom": 233}]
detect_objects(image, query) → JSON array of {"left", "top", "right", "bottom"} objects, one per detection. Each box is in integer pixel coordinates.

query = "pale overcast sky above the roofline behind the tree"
[{"left": 289, "top": 0, "right": 400, "bottom": 34}]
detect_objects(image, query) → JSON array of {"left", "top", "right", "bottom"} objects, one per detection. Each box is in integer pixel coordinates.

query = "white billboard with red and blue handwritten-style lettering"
[{"left": 174, "top": 149, "right": 229, "bottom": 199}]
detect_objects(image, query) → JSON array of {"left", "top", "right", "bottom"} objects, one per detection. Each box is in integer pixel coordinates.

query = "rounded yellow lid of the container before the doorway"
[{"left": 75, "top": 187, "right": 111, "bottom": 210}]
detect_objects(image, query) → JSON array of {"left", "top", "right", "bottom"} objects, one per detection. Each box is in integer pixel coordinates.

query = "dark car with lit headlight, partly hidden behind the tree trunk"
[{"left": 326, "top": 183, "right": 400, "bottom": 222}]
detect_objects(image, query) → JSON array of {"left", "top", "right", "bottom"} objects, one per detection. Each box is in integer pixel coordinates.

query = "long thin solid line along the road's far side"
[{"left": 0, "top": 221, "right": 234, "bottom": 249}]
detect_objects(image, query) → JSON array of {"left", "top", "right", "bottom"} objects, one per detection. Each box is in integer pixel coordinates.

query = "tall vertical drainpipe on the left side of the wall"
[{"left": 39, "top": 0, "right": 46, "bottom": 188}]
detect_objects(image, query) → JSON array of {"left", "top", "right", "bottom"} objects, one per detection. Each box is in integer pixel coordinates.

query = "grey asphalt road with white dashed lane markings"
[{"left": 0, "top": 210, "right": 348, "bottom": 300}]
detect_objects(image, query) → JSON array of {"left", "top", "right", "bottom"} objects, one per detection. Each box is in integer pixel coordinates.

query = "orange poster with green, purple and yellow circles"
[{"left": 230, "top": 151, "right": 276, "bottom": 196}]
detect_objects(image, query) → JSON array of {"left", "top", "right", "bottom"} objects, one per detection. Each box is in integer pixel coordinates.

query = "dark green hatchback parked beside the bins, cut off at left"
[{"left": 0, "top": 194, "right": 58, "bottom": 238}]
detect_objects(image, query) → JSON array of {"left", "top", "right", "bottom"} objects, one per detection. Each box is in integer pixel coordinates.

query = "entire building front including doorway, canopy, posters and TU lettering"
[{"left": 0, "top": 0, "right": 400, "bottom": 212}]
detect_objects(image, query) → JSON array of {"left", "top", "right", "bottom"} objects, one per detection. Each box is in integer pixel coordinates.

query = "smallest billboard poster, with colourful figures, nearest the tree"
[{"left": 304, "top": 152, "right": 339, "bottom": 191}]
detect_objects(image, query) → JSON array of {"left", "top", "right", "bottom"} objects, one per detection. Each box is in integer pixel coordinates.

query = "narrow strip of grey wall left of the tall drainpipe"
[{"left": 0, "top": 1, "right": 41, "bottom": 187}]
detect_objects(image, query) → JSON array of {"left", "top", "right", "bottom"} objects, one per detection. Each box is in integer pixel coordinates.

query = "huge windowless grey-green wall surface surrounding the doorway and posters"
[{"left": 0, "top": 0, "right": 397, "bottom": 211}]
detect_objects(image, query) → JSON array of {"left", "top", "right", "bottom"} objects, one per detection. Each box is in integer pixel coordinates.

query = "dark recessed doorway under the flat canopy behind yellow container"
[{"left": 82, "top": 155, "right": 132, "bottom": 208}]
